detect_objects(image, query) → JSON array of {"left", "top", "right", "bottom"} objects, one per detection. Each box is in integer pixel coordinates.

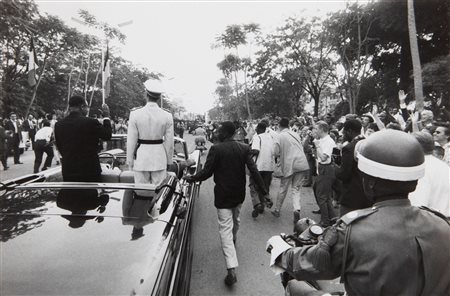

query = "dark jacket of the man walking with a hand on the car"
[{"left": 193, "top": 139, "right": 267, "bottom": 209}]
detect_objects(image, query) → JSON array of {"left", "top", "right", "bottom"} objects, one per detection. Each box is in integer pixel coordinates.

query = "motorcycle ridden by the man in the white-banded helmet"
[{"left": 266, "top": 218, "right": 345, "bottom": 296}]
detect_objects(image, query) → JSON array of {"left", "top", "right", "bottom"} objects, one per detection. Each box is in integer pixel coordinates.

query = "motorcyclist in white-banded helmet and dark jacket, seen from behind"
[{"left": 268, "top": 130, "right": 450, "bottom": 296}]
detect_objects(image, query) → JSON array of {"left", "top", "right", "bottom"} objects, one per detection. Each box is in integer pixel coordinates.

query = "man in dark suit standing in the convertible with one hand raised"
[{"left": 55, "top": 96, "right": 112, "bottom": 182}]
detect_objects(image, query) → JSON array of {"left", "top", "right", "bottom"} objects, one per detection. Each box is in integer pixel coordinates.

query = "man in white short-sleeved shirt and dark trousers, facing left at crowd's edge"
[{"left": 313, "top": 121, "right": 336, "bottom": 227}]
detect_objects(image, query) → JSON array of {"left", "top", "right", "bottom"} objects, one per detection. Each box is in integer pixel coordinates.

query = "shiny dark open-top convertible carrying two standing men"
[{"left": 0, "top": 138, "right": 200, "bottom": 295}]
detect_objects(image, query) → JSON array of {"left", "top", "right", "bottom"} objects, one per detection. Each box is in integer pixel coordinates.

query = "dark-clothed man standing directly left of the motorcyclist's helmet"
[{"left": 335, "top": 119, "right": 372, "bottom": 217}]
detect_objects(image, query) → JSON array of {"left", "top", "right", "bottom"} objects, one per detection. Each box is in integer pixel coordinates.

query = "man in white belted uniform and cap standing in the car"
[{"left": 127, "top": 79, "right": 174, "bottom": 185}]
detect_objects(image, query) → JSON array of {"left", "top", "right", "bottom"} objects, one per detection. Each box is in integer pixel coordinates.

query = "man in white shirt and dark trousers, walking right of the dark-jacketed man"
[{"left": 249, "top": 122, "right": 275, "bottom": 218}]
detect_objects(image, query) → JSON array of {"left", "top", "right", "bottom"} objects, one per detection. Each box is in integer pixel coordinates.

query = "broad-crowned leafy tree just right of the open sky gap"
[{"left": 254, "top": 18, "right": 335, "bottom": 115}]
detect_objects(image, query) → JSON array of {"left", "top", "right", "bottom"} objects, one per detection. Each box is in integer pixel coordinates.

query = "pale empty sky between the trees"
[{"left": 36, "top": 0, "right": 345, "bottom": 114}]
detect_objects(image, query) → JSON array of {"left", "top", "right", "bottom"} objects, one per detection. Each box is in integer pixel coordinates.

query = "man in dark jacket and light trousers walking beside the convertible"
[{"left": 185, "top": 121, "right": 268, "bottom": 286}]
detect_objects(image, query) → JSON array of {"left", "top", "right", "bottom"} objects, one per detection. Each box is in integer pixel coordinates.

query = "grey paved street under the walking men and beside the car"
[{"left": 0, "top": 134, "right": 344, "bottom": 296}]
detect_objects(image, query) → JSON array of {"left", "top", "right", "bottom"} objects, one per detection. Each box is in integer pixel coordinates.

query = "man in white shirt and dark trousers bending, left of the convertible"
[{"left": 33, "top": 120, "right": 53, "bottom": 173}]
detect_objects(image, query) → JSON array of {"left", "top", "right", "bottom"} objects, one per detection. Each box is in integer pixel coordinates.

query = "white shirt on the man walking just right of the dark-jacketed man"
[{"left": 252, "top": 133, "right": 275, "bottom": 172}]
